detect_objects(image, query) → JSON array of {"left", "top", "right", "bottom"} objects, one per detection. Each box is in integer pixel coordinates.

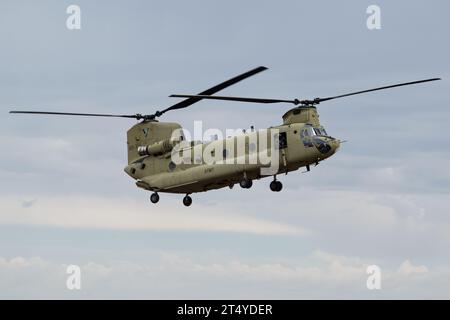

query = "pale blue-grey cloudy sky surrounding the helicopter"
[{"left": 0, "top": 0, "right": 450, "bottom": 299}]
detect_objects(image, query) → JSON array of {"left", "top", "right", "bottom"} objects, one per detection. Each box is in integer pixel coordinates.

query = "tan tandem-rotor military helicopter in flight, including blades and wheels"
[{"left": 10, "top": 66, "right": 441, "bottom": 206}]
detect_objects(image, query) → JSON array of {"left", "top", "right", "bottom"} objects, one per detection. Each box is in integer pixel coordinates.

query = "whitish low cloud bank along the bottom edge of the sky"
[{"left": 0, "top": 251, "right": 450, "bottom": 299}]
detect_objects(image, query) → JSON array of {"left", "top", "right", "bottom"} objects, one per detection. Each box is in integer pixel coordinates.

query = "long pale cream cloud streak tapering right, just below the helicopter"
[{"left": 0, "top": 196, "right": 307, "bottom": 236}]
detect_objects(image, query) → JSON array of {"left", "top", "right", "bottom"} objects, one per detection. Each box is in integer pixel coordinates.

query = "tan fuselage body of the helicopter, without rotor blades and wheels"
[{"left": 125, "top": 107, "right": 340, "bottom": 194}]
